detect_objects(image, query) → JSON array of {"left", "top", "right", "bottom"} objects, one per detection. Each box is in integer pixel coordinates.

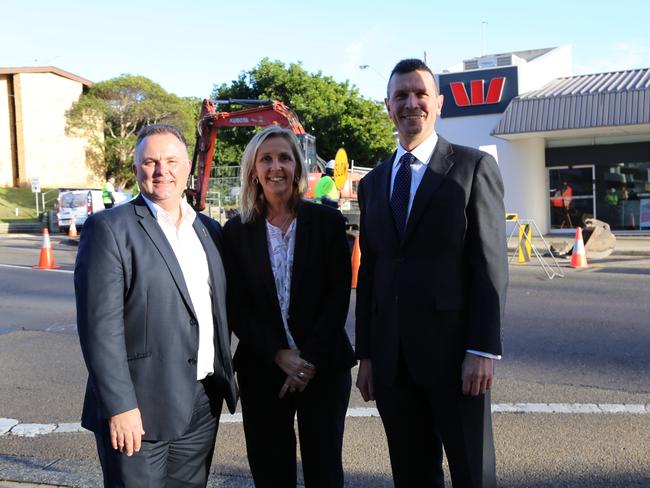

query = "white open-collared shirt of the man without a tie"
[{"left": 142, "top": 195, "right": 214, "bottom": 380}]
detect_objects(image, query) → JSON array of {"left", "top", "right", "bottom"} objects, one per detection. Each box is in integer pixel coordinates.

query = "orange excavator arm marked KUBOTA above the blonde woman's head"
[{"left": 186, "top": 99, "right": 324, "bottom": 211}]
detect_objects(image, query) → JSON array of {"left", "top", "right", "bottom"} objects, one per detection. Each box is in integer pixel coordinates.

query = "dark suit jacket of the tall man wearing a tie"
[{"left": 356, "top": 137, "right": 508, "bottom": 385}]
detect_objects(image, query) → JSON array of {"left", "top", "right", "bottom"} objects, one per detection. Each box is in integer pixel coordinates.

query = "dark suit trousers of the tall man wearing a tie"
[{"left": 374, "top": 358, "right": 496, "bottom": 488}]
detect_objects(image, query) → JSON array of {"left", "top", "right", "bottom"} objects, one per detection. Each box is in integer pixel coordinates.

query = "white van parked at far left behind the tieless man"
[{"left": 55, "top": 188, "right": 133, "bottom": 233}]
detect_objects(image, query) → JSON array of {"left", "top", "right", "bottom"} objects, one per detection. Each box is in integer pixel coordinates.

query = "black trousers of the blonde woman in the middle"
[{"left": 237, "top": 366, "right": 352, "bottom": 488}]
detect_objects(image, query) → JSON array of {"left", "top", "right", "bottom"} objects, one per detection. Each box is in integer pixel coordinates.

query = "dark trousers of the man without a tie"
[{"left": 95, "top": 381, "right": 223, "bottom": 488}]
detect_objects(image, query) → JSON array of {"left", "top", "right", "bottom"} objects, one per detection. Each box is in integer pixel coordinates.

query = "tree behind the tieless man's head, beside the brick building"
[{"left": 67, "top": 74, "right": 200, "bottom": 185}]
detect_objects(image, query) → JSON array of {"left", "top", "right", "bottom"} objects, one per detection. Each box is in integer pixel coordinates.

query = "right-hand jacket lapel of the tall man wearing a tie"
[{"left": 402, "top": 136, "right": 454, "bottom": 245}]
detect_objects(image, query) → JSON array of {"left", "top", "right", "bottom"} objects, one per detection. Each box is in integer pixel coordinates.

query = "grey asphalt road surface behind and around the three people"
[{"left": 0, "top": 236, "right": 650, "bottom": 488}]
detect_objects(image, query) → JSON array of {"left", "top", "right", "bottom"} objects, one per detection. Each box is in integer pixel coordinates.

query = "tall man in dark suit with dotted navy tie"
[{"left": 356, "top": 59, "right": 508, "bottom": 488}]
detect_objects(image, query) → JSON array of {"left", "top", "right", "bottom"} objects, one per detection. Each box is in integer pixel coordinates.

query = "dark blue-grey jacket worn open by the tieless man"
[{"left": 74, "top": 197, "right": 237, "bottom": 440}]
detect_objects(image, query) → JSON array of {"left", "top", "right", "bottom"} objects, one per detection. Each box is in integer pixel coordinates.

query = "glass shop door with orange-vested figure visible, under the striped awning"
[{"left": 548, "top": 165, "right": 597, "bottom": 232}]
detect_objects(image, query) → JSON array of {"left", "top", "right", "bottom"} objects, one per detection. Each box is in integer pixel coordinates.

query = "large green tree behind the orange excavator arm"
[{"left": 212, "top": 58, "right": 395, "bottom": 166}]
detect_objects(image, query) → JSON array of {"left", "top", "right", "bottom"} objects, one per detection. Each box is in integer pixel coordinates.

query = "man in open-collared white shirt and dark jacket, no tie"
[{"left": 75, "top": 125, "right": 237, "bottom": 488}]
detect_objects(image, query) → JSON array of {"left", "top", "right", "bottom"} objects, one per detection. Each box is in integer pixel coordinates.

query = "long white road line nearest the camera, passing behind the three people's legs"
[{"left": 0, "top": 403, "right": 650, "bottom": 437}]
